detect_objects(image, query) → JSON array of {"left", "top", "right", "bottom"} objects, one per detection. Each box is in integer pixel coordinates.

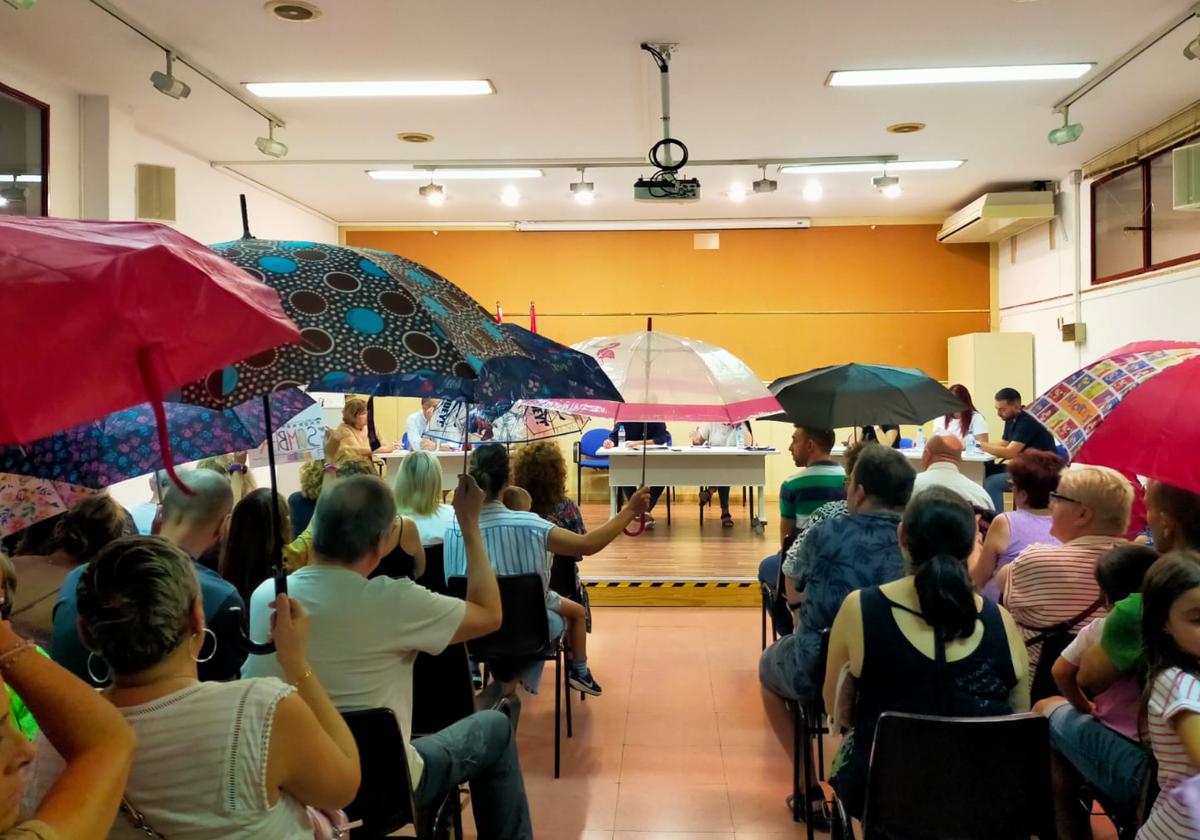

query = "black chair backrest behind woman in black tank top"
[{"left": 863, "top": 712, "right": 1056, "bottom": 840}]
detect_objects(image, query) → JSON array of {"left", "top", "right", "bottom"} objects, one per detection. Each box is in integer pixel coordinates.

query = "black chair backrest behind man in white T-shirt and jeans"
[{"left": 342, "top": 709, "right": 416, "bottom": 836}]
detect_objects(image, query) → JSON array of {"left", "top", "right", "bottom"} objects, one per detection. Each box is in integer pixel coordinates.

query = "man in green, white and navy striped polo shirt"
[{"left": 758, "top": 426, "right": 846, "bottom": 635}]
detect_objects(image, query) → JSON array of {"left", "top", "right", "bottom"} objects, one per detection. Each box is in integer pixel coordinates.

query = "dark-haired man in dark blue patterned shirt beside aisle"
[{"left": 758, "top": 445, "right": 916, "bottom": 703}]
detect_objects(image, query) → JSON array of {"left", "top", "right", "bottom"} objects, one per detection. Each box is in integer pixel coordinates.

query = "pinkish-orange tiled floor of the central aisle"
[{"left": 468, "top": 607, "right": 820, "bottom": 840}]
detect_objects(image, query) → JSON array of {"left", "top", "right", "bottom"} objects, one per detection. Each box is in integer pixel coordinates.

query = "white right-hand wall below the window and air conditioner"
[{"left": 996, "top": 180, "right": 1200, "bottom": 392}]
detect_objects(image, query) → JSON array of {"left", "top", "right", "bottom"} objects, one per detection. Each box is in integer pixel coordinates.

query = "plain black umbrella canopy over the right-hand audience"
[{"left": 767, "top": 362, "right": 966, "bottom": 428}]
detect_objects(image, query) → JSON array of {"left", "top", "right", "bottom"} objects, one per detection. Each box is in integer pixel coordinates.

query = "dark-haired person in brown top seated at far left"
[{"left": 12, "top": 493, "right": 125, "bottom": 643}]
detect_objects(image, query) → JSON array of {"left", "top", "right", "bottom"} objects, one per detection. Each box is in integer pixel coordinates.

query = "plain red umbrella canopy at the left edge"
[{"left": 0, "top": 216, "right": 300, "bottom": 444}]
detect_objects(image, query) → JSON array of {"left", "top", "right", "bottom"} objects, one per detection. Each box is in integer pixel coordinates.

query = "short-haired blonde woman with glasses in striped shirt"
[{"left": 996, "top": 464, "right": 1133, "bottom": 681}]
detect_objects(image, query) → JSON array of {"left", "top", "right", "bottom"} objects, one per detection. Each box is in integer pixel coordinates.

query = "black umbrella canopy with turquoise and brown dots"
[{"left": 182, "top": 239, "right": 535, "bottom": 408}]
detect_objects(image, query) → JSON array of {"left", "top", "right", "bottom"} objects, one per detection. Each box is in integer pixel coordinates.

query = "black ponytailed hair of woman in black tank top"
[{"left": 904, "top": 487, "right": 978, "bottom": 641}]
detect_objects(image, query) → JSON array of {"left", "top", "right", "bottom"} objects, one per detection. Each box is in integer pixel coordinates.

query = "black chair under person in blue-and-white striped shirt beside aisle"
[{"left": 448, "top": 575, "right": 574, "bottom": 779}]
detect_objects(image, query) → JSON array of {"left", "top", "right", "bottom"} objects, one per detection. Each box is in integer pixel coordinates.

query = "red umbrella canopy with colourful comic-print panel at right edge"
[{"left": 1027, "top": 341, "right": 1200, "bottom": 493}]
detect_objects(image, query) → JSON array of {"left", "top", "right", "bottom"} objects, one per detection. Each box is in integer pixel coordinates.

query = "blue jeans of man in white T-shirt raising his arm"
[{"left": 413, "top": 710, "right": 533, "bottom": 840}]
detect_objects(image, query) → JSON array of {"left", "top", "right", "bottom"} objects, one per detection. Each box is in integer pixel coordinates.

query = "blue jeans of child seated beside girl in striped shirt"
[{"left": 1050, "top": 703, "right": 1150, "bottom": 820}]
